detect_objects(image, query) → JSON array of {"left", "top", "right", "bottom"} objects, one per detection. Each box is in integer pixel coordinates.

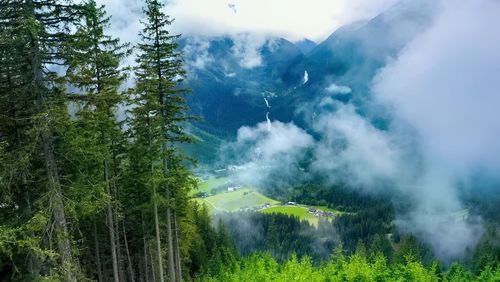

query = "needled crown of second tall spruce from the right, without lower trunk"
[{"left": 65, "top": 1, "right": 130, "bottom": 217}]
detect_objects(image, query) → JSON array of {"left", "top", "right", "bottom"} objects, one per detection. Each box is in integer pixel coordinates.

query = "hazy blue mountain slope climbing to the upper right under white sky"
[{"left": 285, "top": 1, "right": 435, "bottom": 113}]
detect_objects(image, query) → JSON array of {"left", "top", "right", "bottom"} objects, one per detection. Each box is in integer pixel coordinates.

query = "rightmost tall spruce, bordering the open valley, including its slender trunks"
[{"left": 130, "top": 0, "right": 193, "bottom": 281}]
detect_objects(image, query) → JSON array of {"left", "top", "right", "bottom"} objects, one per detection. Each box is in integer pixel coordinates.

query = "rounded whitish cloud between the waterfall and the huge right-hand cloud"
[{"left": 313, "top": 102, "right": 402, "bottom": 189}]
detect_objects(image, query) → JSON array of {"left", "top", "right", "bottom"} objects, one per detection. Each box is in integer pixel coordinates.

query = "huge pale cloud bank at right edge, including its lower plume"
[{"left": 374, "top": 0, "right": 500, "bottom": 258}]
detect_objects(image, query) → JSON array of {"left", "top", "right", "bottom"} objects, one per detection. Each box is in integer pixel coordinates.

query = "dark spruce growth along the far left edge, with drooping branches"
[{"left": 0, "top": 0, "right": 84, "bottom": 280}]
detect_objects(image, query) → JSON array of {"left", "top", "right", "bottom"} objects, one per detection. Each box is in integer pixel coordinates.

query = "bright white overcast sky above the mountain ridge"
[{"left": 98, "top": 0, "right": 397, "bottom": 42}]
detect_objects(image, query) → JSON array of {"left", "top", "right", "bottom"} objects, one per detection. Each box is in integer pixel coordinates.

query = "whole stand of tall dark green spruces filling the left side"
[{"left": 0, "top": 0, "right": 215, "bottom": 281}]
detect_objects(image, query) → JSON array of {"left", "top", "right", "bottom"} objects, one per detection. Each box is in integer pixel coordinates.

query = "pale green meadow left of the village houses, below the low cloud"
[{"left": 195, "top": 188, "right": 279, "bottom": 213}]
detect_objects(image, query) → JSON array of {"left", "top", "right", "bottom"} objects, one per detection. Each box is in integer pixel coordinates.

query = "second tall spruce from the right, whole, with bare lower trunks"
[{"left": 63, "top": 0, "right": 131, "bottom": 281}]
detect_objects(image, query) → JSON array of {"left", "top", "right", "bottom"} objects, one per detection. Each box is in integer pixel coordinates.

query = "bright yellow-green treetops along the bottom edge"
[{"left": 200, "top": 253, "right": 500, "bottom": 282}]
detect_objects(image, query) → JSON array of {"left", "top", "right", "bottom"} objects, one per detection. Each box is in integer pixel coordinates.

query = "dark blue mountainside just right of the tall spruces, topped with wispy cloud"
[{"left": 180, "top": 35, "right": 304, "bottom": 137}]
